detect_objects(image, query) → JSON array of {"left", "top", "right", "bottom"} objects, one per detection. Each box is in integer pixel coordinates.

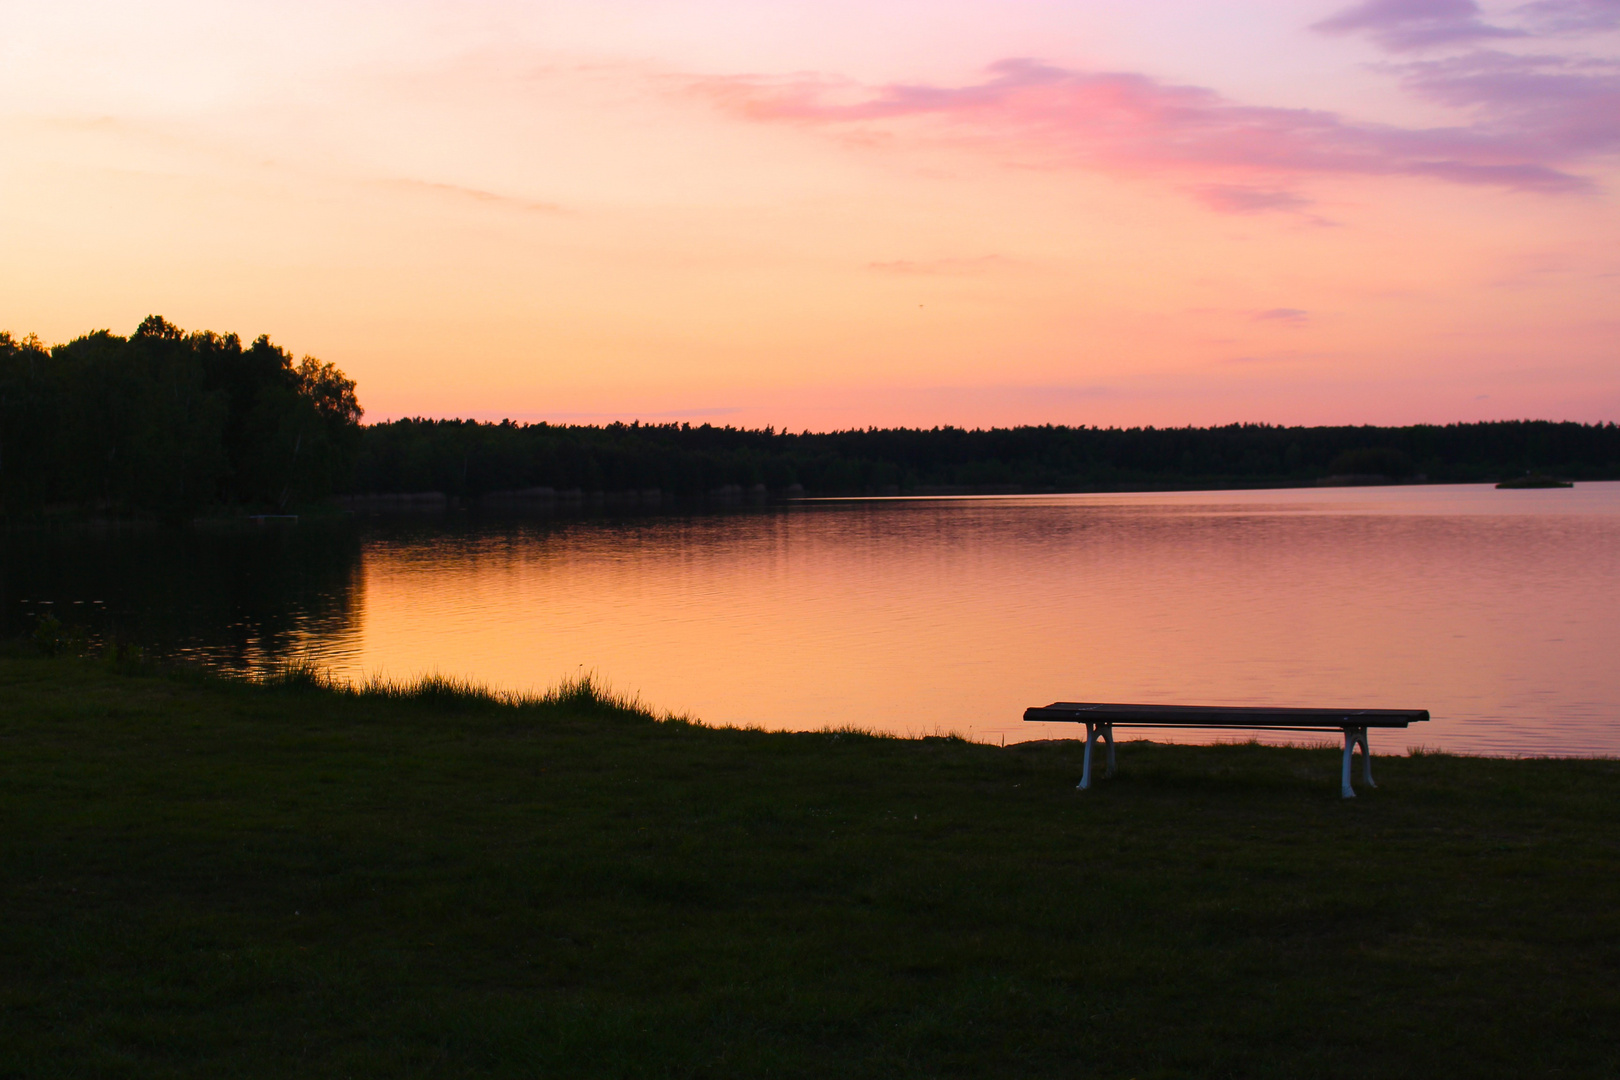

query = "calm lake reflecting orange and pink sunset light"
[{"left": 0, "top": 483, "right": 1620, "bottom": 755}]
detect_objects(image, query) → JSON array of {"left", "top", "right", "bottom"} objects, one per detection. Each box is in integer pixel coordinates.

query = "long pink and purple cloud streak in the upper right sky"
[{"left": 695, "top": 60, "right": 1600, "bottom": 214}]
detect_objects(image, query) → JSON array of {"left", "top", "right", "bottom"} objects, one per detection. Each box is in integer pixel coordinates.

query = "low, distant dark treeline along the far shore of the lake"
[{"left": 353, "top": 419, "right": 1620, "bottom": 499}]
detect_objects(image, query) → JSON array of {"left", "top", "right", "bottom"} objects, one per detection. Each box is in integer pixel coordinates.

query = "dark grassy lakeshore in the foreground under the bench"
[{"left": 0, "top": 657, "right": 1620, "bottom": 1077}]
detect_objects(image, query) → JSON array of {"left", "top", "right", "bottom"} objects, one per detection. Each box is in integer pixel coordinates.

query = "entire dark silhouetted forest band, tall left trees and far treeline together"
[{"left": 0, "top": 316, "right": 1620, "bottom": 513}]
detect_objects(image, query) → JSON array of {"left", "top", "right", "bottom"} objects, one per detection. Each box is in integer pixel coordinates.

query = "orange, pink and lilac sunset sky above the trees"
[{"left": 0, "top": 0, "right": 1620, "bottom": 429}]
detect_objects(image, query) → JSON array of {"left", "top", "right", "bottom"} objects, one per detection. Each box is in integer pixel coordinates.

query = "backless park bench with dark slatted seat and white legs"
[{"left": 1024, "top": 701, "right": 1429, "bottom": 798}]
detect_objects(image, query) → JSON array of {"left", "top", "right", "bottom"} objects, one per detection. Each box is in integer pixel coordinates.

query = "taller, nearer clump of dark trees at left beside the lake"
[{"left": 0, "top": 316, "right": 361, "bottom": 515}]
